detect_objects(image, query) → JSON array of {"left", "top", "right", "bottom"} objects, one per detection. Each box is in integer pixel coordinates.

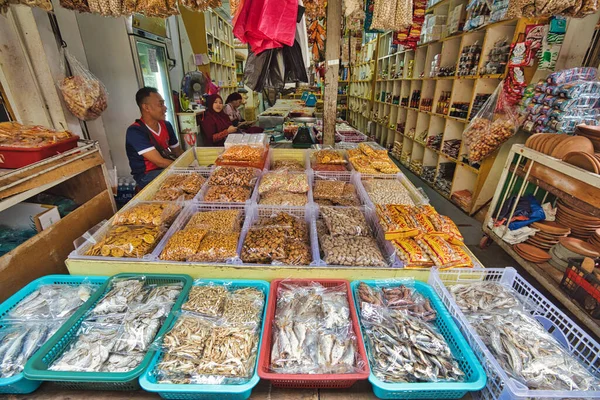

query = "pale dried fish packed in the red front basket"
[{"left": 271, "top": 284, "right": 357, "bottom": 374}]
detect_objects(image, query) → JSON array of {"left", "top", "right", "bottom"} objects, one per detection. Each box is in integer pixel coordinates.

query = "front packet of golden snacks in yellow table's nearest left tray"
[{"left": 85, "top": 225, "right": 165, "bottom": 258}]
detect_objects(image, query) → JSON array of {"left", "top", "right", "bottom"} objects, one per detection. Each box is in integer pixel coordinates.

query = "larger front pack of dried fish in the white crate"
[{"left": 467, "top": 309, "right": 600, "bottom": 391}]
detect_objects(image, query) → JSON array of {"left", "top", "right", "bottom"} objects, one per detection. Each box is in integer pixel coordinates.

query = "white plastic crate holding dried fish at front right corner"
[{"left": 429, "top": 267, "right": 600, "bottom": 400}]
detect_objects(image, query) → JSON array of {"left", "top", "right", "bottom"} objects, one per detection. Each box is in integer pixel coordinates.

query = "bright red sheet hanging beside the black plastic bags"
[{"left": 233, "top": 0, "right": 298, "bottom": 54}]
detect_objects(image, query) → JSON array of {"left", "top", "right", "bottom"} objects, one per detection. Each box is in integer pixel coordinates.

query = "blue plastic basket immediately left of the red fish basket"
[{"left": 140, "top": 279, "right": 269, "bottom": 400}]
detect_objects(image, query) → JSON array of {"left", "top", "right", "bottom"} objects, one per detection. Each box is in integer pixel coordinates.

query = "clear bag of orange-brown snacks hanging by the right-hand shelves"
[{"left": 463, "top": 81, "right": 520, "bottom": 162}]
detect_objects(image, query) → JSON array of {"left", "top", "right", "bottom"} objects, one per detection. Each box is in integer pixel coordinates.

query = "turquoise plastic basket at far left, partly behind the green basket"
[{"left": 0, "top": 275, "right": 108, "bottom": 394}]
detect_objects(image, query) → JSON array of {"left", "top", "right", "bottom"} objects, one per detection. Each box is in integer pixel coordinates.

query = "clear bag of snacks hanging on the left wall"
[{"left": 58, "top": 49, "right": 108, "bottom": 121}]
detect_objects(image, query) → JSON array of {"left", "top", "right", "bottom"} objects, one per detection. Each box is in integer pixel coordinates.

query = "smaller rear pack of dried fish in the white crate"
[{"left": 449, "top": 282, "right": 521, "bottom": 312}]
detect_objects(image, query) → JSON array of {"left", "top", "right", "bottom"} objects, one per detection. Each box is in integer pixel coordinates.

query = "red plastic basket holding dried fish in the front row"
[{"left": 258, "top": 279, "right": 369, "bottom": 389}]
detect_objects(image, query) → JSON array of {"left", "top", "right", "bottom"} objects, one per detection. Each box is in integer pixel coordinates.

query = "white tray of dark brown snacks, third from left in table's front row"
[{"left": 238, "top": 204, "right": 319, "bottom": 266}]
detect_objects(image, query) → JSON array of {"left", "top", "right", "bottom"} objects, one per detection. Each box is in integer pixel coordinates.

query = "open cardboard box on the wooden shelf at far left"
[{"left": 0, "top": 203, "right": 60, "bottom": 232}]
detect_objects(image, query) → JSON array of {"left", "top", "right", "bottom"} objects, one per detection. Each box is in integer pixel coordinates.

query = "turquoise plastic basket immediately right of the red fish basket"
[{"left": 351, "top": 280, "right": 486, "bottom": 399}]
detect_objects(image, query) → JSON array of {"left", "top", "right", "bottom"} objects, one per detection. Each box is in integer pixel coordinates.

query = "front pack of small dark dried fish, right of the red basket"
[{"left": 361, "top": 303, "right": 465, "bottom": 382}]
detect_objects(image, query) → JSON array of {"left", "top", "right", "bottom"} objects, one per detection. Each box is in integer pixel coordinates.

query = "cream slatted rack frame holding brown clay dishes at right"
[{"left": 482, "top": 145, "right": 600, "bottom": 336}]
